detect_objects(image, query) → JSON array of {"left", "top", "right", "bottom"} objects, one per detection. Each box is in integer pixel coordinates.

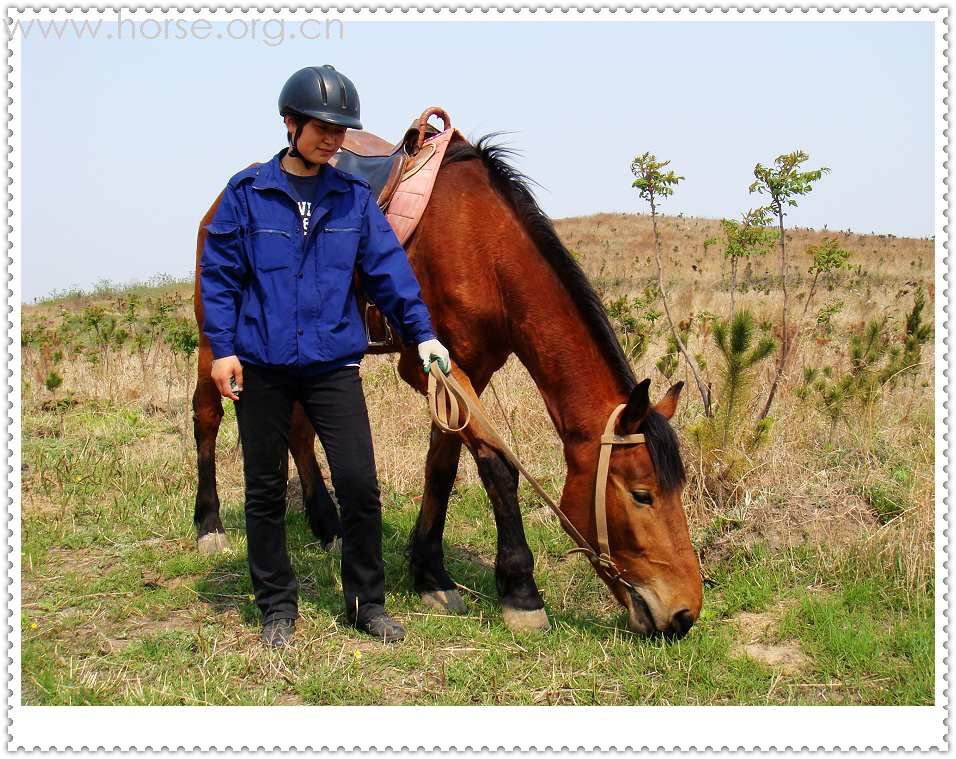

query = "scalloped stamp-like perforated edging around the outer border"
[{"left": 2, "top": 3, "right": 953, "bottom": 753}]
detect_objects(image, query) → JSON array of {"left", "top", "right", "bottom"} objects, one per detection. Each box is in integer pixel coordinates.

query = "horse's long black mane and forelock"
[{"left": 442, "top": 132, "right": 685, "bottom": 493}]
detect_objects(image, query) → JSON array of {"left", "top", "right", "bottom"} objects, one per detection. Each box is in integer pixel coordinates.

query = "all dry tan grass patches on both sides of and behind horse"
[{"left": 23, "top": 214, "right": 935, "bottom": 585}]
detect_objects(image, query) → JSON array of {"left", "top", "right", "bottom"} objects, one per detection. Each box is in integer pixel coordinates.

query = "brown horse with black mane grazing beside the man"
[{"left": 193, "top": 134, "right": 702, "bottom": 636}]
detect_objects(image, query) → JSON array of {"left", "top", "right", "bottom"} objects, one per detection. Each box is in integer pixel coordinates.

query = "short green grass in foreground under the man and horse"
[{"left": 21, "top": 404, "right": 934, "bottom": 704}]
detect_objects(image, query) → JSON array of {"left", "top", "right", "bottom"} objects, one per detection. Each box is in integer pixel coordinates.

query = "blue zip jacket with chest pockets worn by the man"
[{"left": 200, "top": 148, "right": 435, "bottom": 371}]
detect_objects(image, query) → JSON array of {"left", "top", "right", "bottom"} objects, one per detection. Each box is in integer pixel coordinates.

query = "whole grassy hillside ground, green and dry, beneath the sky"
[{"left": 21, "top": 214, "right": 935, "bottom": 704}]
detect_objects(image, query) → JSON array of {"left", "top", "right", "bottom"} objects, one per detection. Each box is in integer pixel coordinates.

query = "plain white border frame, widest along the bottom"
[{"left": 3, "top": 5, "right": 952, "bottom": 751}]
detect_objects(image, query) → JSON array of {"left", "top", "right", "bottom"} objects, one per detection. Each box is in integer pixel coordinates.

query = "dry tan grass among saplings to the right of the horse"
[{"left": 557, "top": 214, "right": 935, "bottom": 587}]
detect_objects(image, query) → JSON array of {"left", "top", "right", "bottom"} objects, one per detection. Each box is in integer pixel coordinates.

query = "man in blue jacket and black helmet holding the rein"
[{"left": 200, "top": 65, "right": 450, "bottom": 646}]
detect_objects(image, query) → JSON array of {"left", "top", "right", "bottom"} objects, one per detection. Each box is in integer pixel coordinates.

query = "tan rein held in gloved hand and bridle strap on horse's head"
[{"left": 428, "top": 359, "right": 644, "bottom": 591}]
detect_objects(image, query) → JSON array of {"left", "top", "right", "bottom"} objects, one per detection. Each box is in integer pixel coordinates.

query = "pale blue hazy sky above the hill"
[{"left": 20, "top": 20, "right": 935, "bottom": 303}]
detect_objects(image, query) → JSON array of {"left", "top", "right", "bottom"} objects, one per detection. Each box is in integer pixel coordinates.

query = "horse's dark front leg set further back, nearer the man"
[{"left": 405, "top": 424, "right": 467, "bottom": 614}]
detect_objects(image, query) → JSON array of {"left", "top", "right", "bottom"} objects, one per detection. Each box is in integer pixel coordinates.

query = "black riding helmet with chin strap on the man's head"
[{"left": 279, "top": 64, "right": 362, "bottom": 165}]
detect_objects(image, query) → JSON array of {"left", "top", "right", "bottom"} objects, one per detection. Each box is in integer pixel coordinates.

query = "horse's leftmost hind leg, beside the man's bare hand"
[{"left": 193, "top": 372, "right": 229, "bottom": 554}]
